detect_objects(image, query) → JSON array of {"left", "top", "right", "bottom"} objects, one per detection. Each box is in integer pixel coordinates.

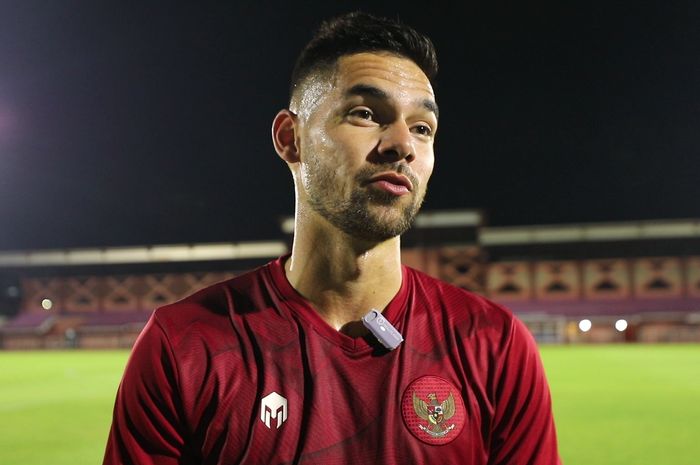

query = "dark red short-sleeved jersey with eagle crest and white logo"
[{"left": 104, "top": 259, "right": 560, "bottom": 465}]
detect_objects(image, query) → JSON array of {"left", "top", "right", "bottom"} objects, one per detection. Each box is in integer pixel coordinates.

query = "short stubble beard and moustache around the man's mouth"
[{"left": 307, "top": 165, "right": 425, "bottom": 242}]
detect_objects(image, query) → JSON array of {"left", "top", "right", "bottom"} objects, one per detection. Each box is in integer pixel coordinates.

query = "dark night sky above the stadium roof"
[{"left": 0, "top": 0, "right": 700, "bottom": 250}]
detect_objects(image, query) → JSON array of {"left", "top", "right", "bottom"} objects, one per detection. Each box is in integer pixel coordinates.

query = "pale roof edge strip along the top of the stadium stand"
[{"left": 0, "top": 210, "right": 700, "bottom": 267}]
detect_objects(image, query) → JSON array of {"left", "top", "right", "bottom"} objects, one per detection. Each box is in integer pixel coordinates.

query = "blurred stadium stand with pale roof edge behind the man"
[{"left": 0, "top": 210, "right": 700, "bottom": 349}]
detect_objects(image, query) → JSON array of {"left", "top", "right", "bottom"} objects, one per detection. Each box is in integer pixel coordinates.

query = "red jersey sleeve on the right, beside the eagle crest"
[{"left": 489, "top": 318, "right": 561, "bottom": 465}]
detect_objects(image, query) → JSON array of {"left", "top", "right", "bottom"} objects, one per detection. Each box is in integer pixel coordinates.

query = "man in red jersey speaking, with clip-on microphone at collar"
[{"left": 104, "top": 13, "right": 559, "bottom": 465}]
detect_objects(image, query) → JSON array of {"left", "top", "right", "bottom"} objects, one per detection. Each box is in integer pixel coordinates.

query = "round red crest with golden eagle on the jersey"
[{"left": 401, "top": 376, "right": 465, "bottom": 445}]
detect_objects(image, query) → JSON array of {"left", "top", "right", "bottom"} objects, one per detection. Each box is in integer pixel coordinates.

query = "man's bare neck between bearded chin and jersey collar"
[{"left": 285, "top": 208, "right": 402, "bottom": 335}]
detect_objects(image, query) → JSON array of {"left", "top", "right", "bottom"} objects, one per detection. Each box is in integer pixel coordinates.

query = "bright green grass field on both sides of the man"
[{"left": 0, "top": 345, "right": 700, "bottom": 465}]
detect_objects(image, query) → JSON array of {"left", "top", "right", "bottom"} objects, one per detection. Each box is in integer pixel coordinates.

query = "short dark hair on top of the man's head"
[{"left": 289, "top": 11, "right": 438, "bottom": 98}]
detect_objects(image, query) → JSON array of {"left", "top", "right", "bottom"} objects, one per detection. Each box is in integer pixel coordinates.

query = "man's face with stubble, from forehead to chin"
[{"left": 298, "top": 53, "right": 437, "bottom": 241}]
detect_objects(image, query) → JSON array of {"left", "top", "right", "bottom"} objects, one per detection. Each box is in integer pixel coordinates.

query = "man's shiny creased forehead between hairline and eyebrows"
[{"left": 334, "top": 53, "right": 435, "bottom": 100}]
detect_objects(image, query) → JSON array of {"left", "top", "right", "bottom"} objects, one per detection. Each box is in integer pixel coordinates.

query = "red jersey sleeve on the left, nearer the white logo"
[{"left": 103, "top": 314, "right": 187, "bottom": 465}]
